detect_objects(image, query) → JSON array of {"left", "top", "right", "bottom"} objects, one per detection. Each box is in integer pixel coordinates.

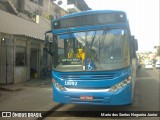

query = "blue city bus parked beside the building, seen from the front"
[{"left": 46, "top": 10, "right": 137, "bottom": 105}]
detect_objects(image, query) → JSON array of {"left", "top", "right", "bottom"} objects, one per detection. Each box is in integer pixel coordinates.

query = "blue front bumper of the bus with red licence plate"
[{"left": 53, "top": 84, "right": 133, "bottom": 105}]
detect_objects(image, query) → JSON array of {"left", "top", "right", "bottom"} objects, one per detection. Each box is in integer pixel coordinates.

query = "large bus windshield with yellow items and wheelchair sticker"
[{"left": 54, "top": 28, "right": 130, "bottom": 71}]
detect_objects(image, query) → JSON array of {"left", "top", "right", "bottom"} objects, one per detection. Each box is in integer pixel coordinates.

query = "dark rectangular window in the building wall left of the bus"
[{"left": 16, "top": 47, "right": 26, "bottom": 66}]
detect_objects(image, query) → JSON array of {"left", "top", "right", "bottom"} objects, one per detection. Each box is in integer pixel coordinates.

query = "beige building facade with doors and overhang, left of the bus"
[{"left": 0, "top": 0, "right": 67, "bottom": 84}]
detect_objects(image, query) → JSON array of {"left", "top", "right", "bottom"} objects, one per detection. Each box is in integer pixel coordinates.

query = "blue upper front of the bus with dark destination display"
[{"left": 52, "top": 10, "right": 129, "bottom": 34}]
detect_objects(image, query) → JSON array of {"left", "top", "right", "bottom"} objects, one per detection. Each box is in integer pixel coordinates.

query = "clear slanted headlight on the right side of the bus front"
[{"left": 108, "top": 76, "right": 131, "bottom": 92}]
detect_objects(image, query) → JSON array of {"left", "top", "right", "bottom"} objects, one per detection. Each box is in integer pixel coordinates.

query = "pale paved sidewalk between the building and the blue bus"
[{"left": 0, "top": 79, "right": 56, "bottom": 112}]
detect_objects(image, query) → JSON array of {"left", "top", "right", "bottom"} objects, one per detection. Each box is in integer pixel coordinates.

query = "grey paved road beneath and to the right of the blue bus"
[{"left": 45, "top": 68, "right": 160, "bottom": 120}]
